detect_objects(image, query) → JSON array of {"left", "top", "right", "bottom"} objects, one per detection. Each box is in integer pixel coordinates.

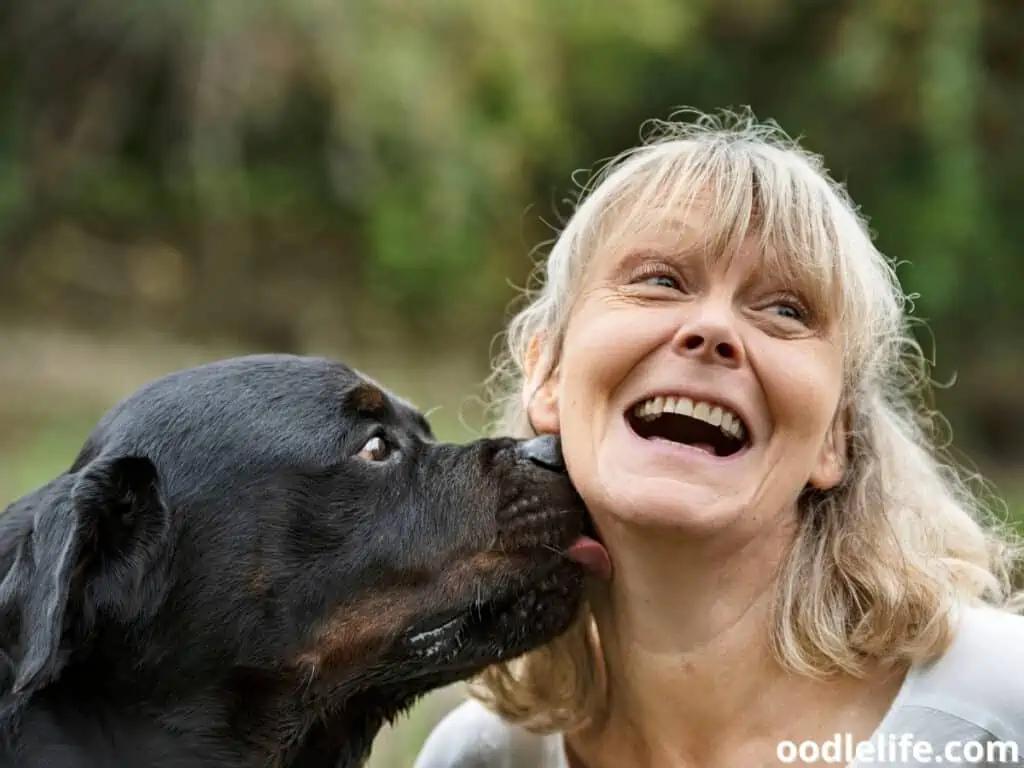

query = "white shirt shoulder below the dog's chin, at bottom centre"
[{"left": 413, "top": 699, "right": 564, "bottom": 768}]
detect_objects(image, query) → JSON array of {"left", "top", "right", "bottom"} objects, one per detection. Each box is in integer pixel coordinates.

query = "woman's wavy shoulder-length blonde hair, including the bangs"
[{"left": 471, "top": 111, "right": 1020, "bottom": 732}]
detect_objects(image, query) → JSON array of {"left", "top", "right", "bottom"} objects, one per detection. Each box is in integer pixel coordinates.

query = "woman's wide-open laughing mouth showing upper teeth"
[{"left": 626, "top": 395, "right": 751, "bottom": 458}]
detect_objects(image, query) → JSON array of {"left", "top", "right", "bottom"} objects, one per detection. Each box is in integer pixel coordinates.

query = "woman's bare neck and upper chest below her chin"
[{"left": 567, "top": 524, "right": 899, "bottom": 768}]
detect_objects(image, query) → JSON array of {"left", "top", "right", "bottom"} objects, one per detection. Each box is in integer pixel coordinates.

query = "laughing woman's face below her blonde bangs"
[{"left": 529, "top": 205, "right": 845, "bottom": 537}]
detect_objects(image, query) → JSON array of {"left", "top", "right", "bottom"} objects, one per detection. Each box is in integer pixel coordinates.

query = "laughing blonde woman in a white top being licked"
[{"left": 416, "top": 109, "right": 1024, "bottom": 768}]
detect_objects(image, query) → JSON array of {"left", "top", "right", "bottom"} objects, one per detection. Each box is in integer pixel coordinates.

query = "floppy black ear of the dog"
[{"left": 0, "top": 456, "right": 168, "bottom": 710}]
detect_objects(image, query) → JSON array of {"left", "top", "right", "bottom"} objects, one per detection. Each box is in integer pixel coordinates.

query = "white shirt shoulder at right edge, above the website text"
[{"left": 901, "top": 606, "right": 1024, "bottom": 744}]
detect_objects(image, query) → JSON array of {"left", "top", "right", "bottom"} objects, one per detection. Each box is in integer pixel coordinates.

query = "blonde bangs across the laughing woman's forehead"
[{"left": 567, "top": 137, "right": 856, "bottom": 347}]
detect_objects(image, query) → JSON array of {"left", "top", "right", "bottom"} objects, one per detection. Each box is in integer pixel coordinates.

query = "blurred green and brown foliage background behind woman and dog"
[{"left": 0, "top": 0, "right": 1024, "bottom": 765}]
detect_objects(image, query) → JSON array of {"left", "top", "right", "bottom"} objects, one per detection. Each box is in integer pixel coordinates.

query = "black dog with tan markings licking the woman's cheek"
[{"left": 0, "top": 355, "right": 597, "bottom": 768}]
